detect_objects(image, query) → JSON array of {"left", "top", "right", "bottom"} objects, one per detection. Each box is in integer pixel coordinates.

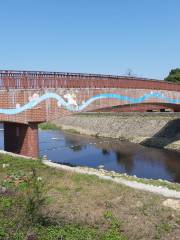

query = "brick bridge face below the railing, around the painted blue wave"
[{"left": 0, "top": 88, "right": 180, "bottom": 124}]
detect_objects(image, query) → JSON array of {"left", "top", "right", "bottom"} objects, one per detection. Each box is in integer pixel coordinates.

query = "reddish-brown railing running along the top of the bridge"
[{"left": 0, "top": 71, "right": 180, "bottom": 91}]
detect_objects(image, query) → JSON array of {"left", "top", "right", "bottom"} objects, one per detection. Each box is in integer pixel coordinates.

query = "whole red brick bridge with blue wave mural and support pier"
[{"left": 0, "top": 71, "right": 180, "bottom": 157}]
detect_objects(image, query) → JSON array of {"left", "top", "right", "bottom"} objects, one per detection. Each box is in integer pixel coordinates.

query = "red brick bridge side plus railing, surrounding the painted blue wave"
[{"left": 0, "top": 71, "right": 180, "bottom": 124}]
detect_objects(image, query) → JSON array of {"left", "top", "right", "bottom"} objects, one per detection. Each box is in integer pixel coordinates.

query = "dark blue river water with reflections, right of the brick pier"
[{"left": 39, "top": 131, "right": 180, "bottom": 182}]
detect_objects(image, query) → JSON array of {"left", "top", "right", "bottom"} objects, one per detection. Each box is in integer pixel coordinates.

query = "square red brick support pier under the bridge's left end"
[{"left": 4, "top": 122, "right": 39, "bottom": 158}]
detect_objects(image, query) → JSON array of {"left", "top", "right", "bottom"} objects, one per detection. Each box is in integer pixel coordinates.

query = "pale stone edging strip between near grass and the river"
[{"left": 43, "top": 160, "right": 180, "bottom": 197}]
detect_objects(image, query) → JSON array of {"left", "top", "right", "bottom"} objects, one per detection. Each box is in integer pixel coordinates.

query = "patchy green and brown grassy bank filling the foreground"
[{"left": 0, "top": 155, "right": 180, "bottom": 240}]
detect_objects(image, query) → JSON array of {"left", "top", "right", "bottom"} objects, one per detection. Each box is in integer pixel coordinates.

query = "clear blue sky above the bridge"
[{"left": 0, "top": 0, "right": 180, "bottom": 79}]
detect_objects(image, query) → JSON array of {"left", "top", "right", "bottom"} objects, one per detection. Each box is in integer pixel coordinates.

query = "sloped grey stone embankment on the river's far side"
[{"left": 53, "top": 113, "right": 180, "bottom": 150}]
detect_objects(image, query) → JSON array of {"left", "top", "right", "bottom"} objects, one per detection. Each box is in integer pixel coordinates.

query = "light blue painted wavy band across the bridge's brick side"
[{"left": 0, "top": 92, "right": 180, "bottom": 115}]
